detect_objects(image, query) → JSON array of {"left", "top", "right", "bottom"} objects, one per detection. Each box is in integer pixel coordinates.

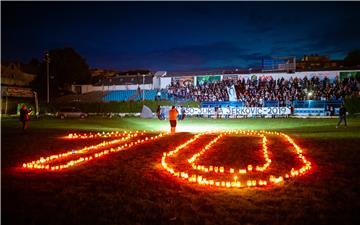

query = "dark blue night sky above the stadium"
[{"left": 1, "top": 2, "right": 360, "bottom": 71}]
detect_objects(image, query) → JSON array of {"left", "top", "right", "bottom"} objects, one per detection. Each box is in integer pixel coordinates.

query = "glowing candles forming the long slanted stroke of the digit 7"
[{"left": 22, "top": 131, "right": 164, "bottom": 171}]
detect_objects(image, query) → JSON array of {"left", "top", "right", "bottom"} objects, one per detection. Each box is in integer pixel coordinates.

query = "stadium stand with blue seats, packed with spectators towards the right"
[{"left": 66, "top": 71, "right": 360, "bottom": 116}]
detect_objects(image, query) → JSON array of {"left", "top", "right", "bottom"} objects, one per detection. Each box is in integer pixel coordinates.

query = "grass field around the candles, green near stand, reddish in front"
[{"left": 1, "top": 118, "right": 360, "bottom": 225}]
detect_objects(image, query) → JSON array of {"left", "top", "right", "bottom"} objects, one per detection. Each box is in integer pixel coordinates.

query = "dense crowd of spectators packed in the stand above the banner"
[{"left": 168, "top": 77, "right": 360, "bottom": 107}]
